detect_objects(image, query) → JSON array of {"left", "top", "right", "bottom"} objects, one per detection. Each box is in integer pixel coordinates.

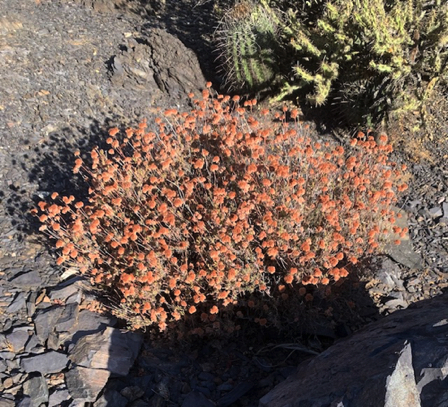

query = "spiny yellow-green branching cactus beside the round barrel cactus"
[{"left": 266, "top": 0, "right": 448, "bottom": 124}]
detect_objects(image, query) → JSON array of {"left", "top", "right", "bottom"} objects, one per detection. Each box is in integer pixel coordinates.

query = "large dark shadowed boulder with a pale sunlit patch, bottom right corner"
[{"left": 259, "top": 293, "right": 448, "bottom": 407}]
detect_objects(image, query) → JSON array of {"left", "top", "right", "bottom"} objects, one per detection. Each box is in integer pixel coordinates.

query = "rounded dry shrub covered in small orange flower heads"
[{"left": 35, "top": 84, "right": 405, "bottom": 330}]
